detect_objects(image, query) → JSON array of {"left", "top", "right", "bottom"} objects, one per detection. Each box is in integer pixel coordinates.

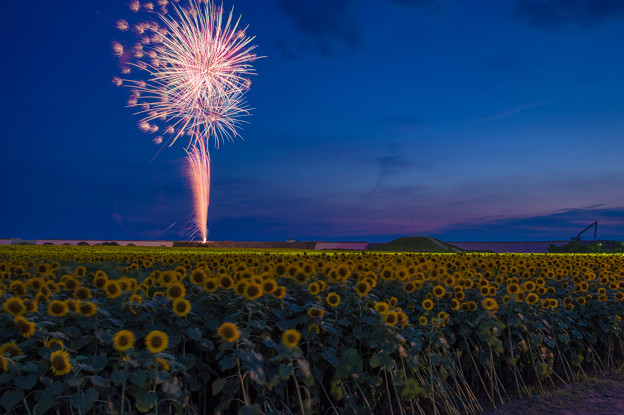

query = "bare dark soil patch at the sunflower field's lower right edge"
[{"left": 484, "top": 370, "right": 624, "bottom": 415}]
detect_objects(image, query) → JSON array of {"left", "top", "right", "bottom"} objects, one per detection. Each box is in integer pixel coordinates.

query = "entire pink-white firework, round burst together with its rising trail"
[{"left": 112, "top": 0, "right": 257, "bottom": 242}]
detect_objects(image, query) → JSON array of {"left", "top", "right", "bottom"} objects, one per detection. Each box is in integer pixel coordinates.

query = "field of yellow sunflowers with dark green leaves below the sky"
[{"left": 0, "top": 246, "right": 624, "bottom": 415}]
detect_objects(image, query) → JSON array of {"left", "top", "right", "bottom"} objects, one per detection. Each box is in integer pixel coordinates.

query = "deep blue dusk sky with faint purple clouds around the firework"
[{"left": 0, "top": 0, "right": 624, "bottom": 242}]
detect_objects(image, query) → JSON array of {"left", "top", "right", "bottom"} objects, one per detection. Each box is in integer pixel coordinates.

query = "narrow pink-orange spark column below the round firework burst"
[{"left": 187, "top": 136, "right": 210, "bottom": 243}]
